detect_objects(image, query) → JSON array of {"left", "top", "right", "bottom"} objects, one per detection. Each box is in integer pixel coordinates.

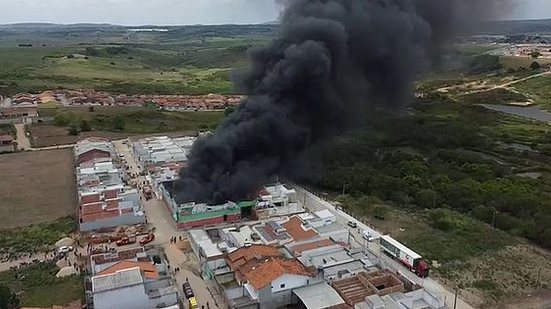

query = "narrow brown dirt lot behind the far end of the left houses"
[{"left": 28, "top": 124, "right": 135, "bottom": 148}]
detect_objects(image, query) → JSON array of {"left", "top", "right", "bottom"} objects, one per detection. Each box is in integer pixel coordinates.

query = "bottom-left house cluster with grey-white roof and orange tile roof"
[{"left": 85, "top": 247, "right": 179, "bottom": 309}]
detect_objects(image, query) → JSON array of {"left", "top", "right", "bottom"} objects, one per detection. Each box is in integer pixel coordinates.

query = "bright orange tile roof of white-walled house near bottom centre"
[{"left": 244, "top": 258, "right": 311, "bottom": 290}]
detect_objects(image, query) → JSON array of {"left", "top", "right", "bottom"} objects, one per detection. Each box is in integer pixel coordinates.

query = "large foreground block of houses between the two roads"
[{"left": 190, "top": 210, "right": 445, "bottom": 309}]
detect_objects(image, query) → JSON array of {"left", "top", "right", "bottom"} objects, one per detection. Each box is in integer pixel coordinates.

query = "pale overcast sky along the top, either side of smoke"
[{"left": 0, "top": 0, "right": 551, "bottom": 25}]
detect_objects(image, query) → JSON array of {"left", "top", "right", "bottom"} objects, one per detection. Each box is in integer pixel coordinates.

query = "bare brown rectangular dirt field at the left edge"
[{"left": 0, "top": 149, "right": 76, "bottom": 228}]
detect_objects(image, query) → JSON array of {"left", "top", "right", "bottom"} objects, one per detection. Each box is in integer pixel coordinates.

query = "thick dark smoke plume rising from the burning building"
[{"left": 175, "top": 0, "right": 512, "bottom": 203}]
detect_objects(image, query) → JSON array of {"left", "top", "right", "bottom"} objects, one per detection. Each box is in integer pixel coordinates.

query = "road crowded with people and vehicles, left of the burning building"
[{"left": 113, "top": 140, "right": 224, "bottom": 308}]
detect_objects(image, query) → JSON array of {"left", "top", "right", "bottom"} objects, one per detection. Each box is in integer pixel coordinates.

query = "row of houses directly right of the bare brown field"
[{"left": 74, "top": 138, "right": 145, "bottom": 231}]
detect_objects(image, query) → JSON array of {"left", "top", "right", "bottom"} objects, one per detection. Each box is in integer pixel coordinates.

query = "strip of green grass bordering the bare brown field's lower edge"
[{"left": 0, "top": 217, "right": 76, "bottom": 252}]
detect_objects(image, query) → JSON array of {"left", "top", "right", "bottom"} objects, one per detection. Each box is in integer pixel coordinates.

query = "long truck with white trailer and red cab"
[{"left": 381, "top": 235, "right": 430, "bottom": 278}]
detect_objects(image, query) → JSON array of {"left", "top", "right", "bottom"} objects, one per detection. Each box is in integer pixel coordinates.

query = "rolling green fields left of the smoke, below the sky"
[{"left": 0, "top": 26, "right": 273, "bottom": 95}]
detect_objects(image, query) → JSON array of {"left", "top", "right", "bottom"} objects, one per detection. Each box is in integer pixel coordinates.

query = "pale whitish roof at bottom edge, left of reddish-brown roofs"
[{"left": 293, "top": 282, "right": 344, "bottom": 309}]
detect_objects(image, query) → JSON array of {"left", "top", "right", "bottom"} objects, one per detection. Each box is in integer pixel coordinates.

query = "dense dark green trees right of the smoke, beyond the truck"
[{"left": 307, "top": 100, "right": 551, "bottom": 248}]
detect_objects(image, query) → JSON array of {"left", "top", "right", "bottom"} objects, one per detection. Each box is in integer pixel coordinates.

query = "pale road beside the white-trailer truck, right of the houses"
[{"left": 295, "top": 186, "right": 473, "bottom": 309}]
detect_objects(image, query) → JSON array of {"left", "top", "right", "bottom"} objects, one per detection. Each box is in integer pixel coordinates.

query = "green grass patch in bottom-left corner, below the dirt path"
[{"left": 0, "top": 262, "right": 84, "bottom": 307}]
